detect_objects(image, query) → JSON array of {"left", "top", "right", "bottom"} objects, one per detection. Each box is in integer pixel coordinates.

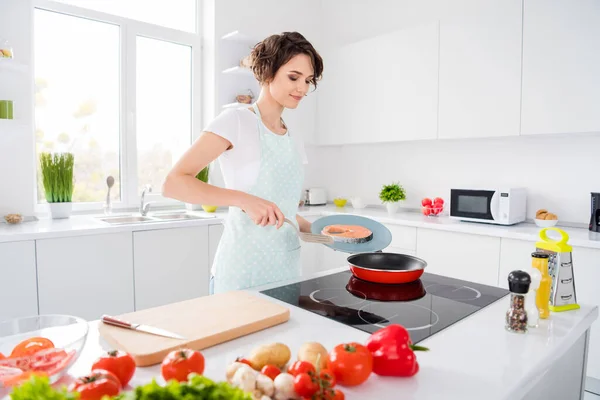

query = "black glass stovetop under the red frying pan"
[{"left": 261, "top": 271, "right": 509, "bottom": 343}]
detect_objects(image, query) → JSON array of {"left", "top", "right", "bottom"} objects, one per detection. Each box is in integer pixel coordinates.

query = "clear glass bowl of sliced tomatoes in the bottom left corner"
[{"left": 0, "top": 314, "right": 89, "bottom": 389}]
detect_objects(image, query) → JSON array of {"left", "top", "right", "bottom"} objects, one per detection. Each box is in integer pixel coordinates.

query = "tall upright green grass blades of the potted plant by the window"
[{"left": 40, "top": 153, "right": 75, "bottom": 203}]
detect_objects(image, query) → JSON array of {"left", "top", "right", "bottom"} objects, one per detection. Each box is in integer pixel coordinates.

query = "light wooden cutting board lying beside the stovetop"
[{"left": 98, "top": 291, "right": 290, "bottom": 367}]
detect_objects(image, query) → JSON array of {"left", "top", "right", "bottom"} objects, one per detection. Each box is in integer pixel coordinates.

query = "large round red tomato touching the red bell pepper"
[{"left": 327, "top": 342, "right": 373, "bottom": 386}]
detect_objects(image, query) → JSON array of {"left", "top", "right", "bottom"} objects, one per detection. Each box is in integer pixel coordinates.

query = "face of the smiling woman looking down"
[{"left": 269, "top": 54, "right": 314, "bottom": 108}]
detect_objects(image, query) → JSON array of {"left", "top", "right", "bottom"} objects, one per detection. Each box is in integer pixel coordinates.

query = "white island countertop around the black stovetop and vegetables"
[{"left": 57, "top": 268, "right": 598, "bottom": 400}]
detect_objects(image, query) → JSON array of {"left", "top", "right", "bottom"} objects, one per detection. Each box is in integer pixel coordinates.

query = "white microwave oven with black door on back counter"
[{"left": 450, "top": 188, "right": 527, "bottom": 225}]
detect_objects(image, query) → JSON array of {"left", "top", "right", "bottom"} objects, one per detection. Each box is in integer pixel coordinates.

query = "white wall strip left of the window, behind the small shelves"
[{"left": 0, "top": 0, "right": 35, "bottom": 217}]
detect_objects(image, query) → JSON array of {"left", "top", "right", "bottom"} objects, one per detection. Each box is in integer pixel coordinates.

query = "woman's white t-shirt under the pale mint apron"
[{"left": 203, "top": 105, "right": 308, "bottom": 192}]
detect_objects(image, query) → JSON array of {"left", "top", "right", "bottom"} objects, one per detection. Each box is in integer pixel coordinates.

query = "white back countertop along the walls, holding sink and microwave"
[{"left": 0, "top": 205, "right": 600, "bottom": 249}]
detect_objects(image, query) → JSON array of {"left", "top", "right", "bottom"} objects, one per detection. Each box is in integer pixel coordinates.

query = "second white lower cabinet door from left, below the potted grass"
[{"left": 36, "top": 232, "right": 134, "bottom": 320}]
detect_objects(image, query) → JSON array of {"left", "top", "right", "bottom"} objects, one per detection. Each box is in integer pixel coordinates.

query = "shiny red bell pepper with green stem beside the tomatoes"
[{"left": 366, "top": 324, "right": 429, "bottom": 376}]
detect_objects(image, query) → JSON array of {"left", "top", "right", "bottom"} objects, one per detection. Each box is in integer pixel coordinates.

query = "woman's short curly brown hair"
[{"left": 249, "top": 32, "right": 323, "bottom": 88}]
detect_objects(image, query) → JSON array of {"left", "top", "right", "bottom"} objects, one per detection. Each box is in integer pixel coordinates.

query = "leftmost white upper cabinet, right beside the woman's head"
[{"left": 317, "top": 21, "right": 439, "bottom": 145}]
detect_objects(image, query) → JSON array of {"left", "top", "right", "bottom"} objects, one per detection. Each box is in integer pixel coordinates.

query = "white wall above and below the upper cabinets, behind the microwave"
[{"left": 305, "top": 0, "right": 600, "bottom": 224}]
